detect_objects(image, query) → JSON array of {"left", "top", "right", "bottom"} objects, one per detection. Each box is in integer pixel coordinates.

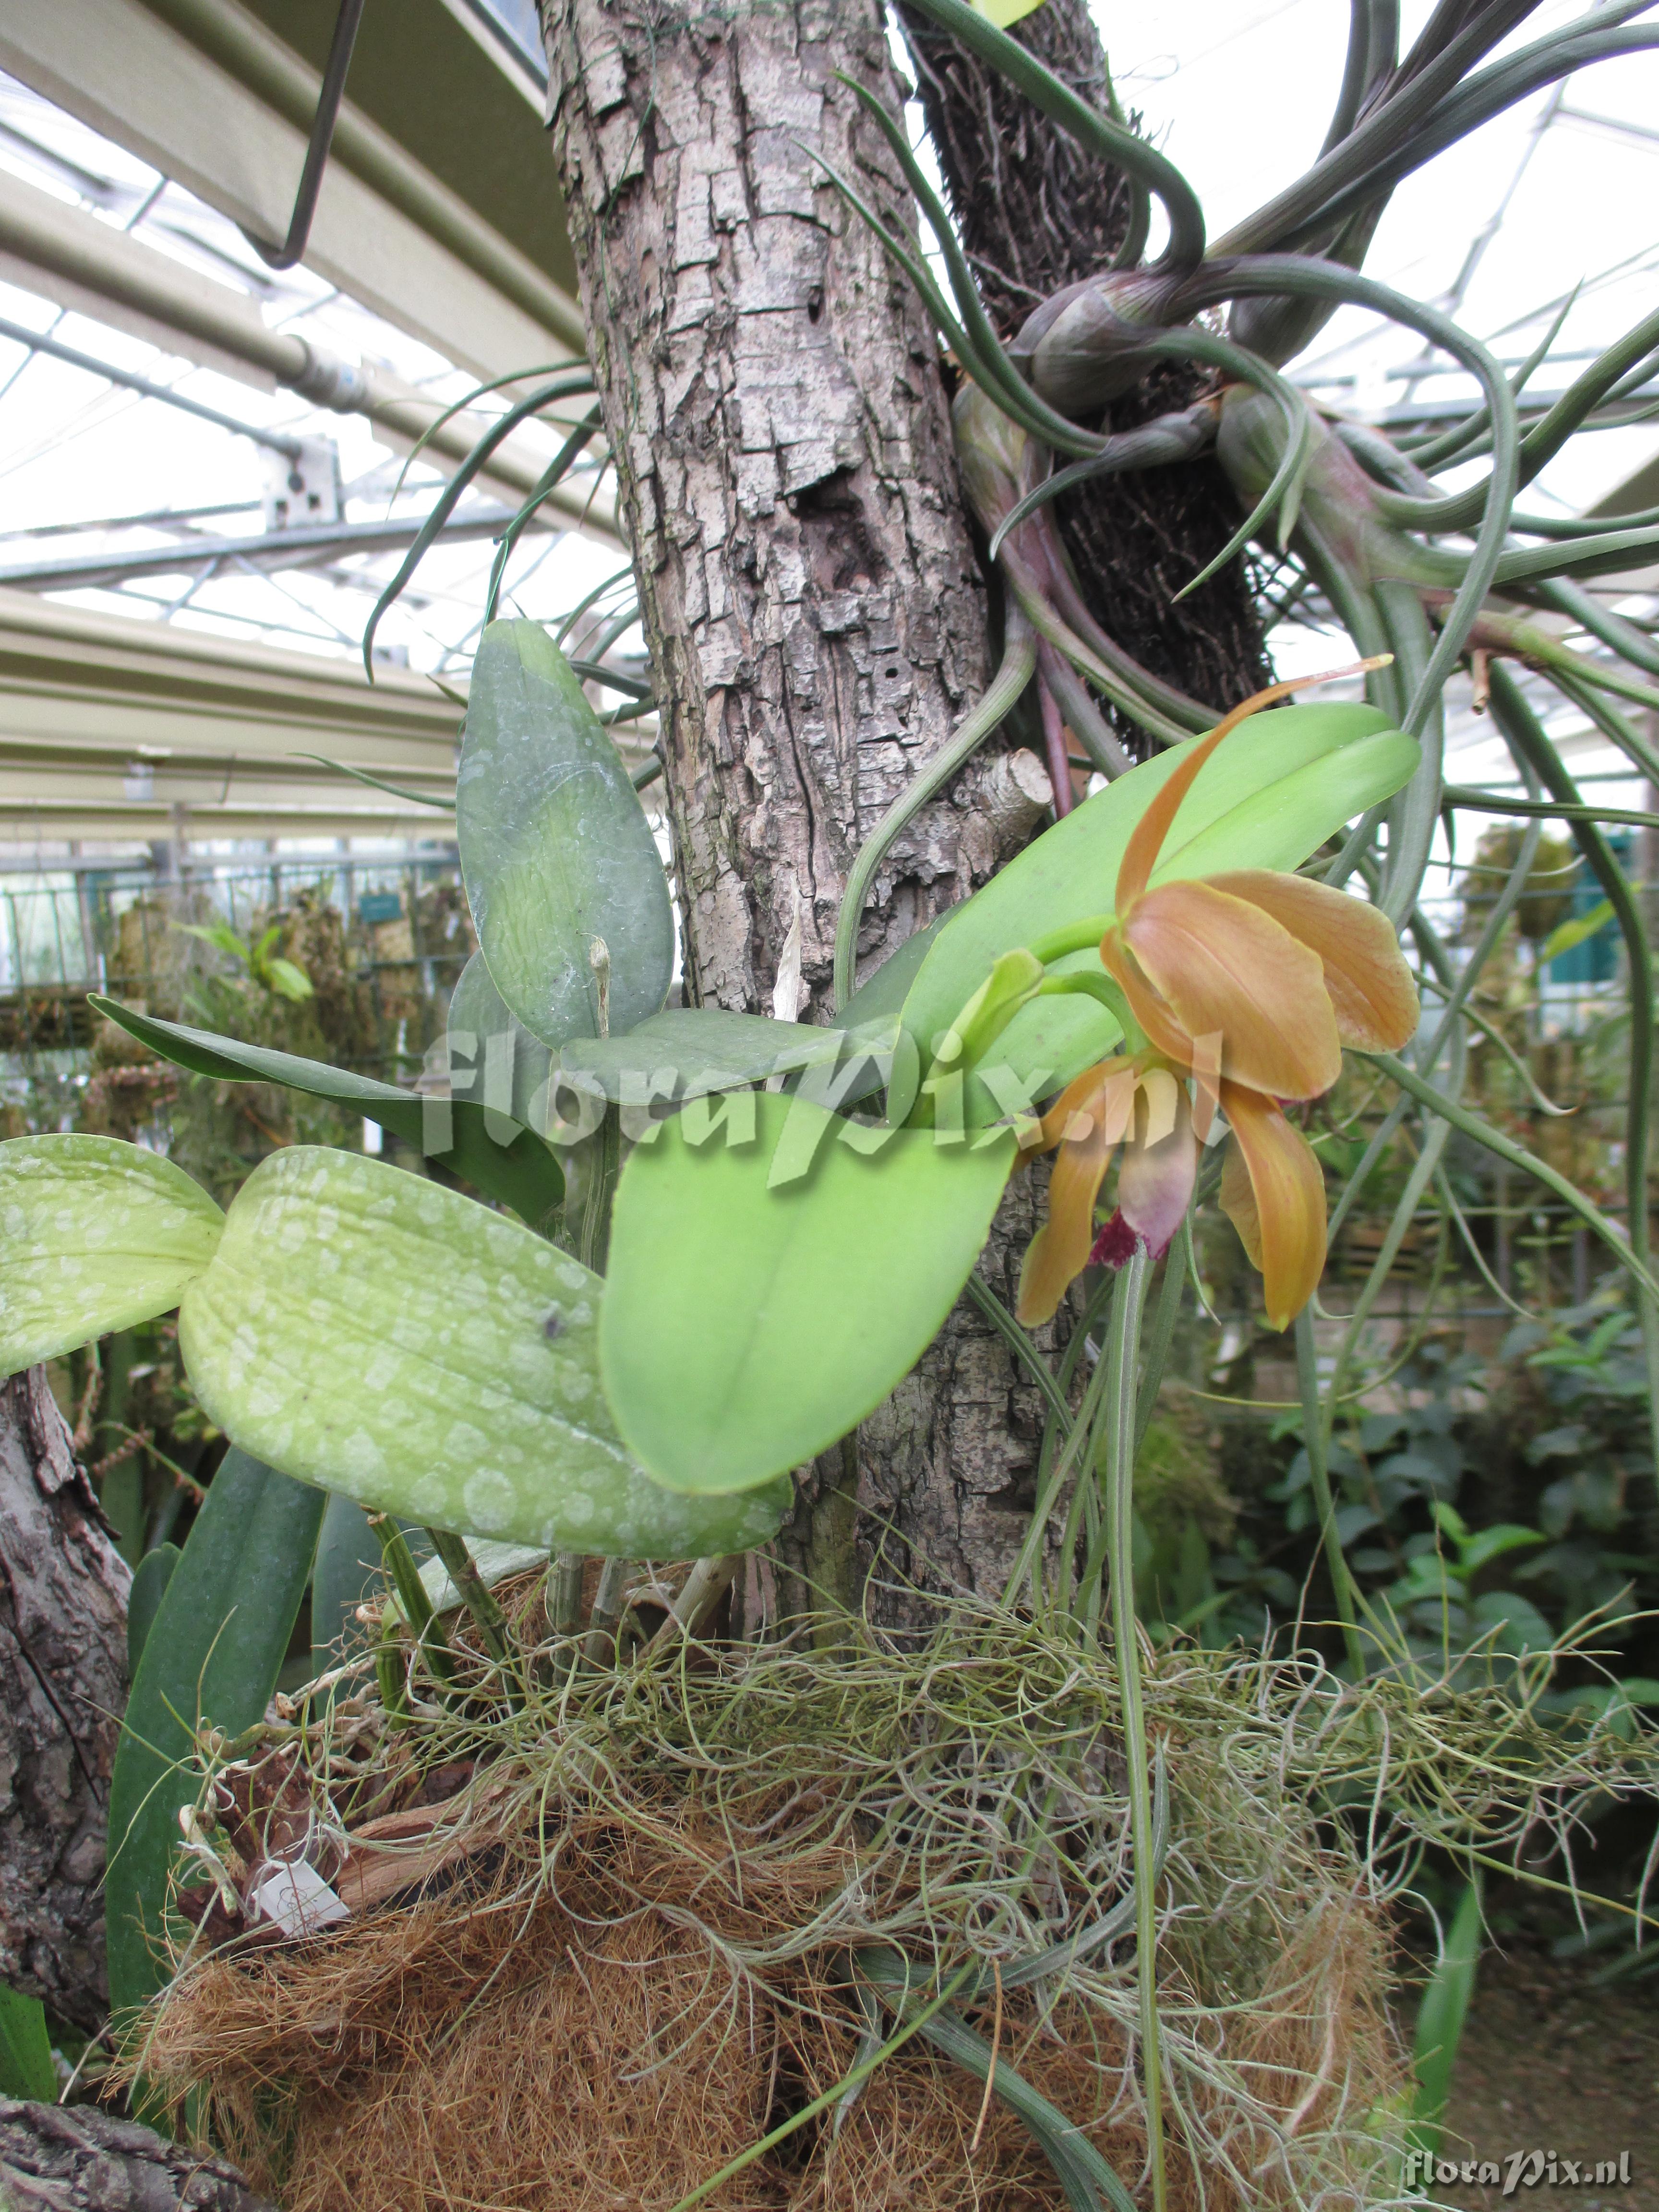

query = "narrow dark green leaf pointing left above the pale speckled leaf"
[{"left": 88, "top": 993, "right": 564, "bottom": 1227}]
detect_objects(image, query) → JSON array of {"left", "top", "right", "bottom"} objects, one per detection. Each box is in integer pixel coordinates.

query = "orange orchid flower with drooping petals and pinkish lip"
[{"left": 1018, "top": 661, "right": 1418, "bottom": 1329}]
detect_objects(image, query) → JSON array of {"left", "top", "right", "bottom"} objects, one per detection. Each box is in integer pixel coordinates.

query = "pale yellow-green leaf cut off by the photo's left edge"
[{"left": 0, "top": 1135, "right": 226, "bottom": 1374}]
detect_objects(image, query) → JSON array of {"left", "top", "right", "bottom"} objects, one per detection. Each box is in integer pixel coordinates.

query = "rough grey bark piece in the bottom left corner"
[{"left": 0, "top": 2099, "right": 276, "bottom": 2212}]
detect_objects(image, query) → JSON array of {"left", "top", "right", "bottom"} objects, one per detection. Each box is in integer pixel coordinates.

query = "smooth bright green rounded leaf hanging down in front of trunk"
[{"left": 600, "top": 1093, "right": 1013, "bottom": 1491}]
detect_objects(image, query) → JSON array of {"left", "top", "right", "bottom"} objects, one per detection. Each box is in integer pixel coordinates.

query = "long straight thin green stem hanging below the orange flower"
[{"left": 1082, "top": 1245, "right": 1164, "bottom": 2212}]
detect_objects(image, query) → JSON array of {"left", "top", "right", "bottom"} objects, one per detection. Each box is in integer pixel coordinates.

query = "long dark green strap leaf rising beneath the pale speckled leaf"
[{"left": 104, "top": 1451, "right": 325, "bottom": 2015}]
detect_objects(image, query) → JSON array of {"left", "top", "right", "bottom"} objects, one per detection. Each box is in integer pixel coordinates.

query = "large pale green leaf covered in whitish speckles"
[{"left": 179, "top": 1146, "right": 787, "bottom": 1560}]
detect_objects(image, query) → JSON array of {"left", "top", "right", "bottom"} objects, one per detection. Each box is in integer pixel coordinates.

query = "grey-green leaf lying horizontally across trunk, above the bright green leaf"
[{"left": 560, "top": 1007, "right": 898, "bottom": 1104}]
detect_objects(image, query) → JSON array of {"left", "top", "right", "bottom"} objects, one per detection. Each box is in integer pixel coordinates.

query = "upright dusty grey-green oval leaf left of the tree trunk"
[{"left": 456, "top": 622, "right": 674, "bottom": 1046}]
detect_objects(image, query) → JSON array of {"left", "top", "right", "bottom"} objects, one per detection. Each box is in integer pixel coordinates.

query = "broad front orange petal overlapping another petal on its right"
[{"left": 1121, "top": 883, "right": 1343, "bottom": 1099}]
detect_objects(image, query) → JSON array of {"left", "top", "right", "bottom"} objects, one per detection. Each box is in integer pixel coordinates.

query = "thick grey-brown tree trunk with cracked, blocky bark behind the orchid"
[{"left": 544, "top": 0, "right": 1066, "bottom": 1628}]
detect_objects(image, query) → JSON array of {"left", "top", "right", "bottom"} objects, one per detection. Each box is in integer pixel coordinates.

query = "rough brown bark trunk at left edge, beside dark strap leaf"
[{"left": 0, "top": 1367, "right": 132, "bottom": 2033}]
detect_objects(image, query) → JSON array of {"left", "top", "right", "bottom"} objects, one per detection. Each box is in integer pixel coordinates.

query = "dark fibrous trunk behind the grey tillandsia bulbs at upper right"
[{"left": 902, "top": 0, "right": 1270, "bottom": 734}]
